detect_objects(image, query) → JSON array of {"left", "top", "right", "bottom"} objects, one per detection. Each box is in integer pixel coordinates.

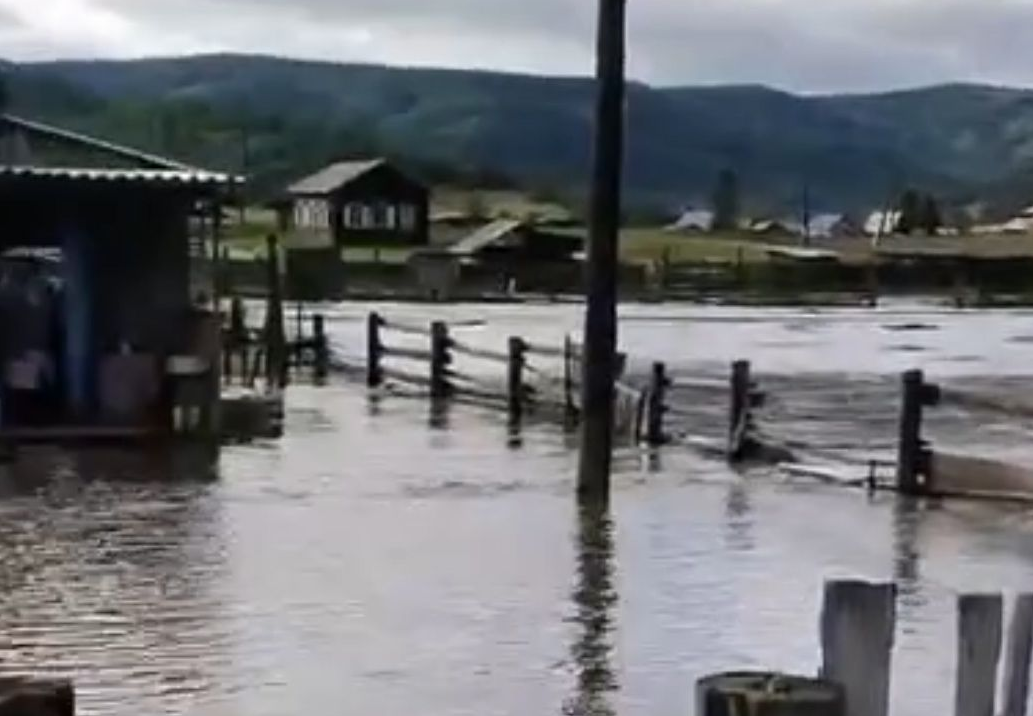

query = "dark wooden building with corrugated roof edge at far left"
[{"left": 0, "top": 115, "right": 239, "bottom": 439}]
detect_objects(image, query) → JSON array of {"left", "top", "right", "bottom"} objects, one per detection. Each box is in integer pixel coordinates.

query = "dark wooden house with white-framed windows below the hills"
[{"left": 287, "top": 159, "right": 430, "bottom": 248}]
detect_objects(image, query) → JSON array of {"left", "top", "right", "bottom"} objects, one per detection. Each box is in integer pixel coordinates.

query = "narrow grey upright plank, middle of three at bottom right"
[{"left": 954, "top": 594, "right": 1004, "bottom": 716}]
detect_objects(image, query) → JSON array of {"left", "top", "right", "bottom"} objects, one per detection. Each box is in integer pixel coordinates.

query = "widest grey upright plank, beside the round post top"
[{"left": 821, "top": 582, "right": 897, "bottom": 716}]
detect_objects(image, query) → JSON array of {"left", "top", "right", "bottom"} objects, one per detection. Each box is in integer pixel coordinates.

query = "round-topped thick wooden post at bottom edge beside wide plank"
[{"left": 696, "top": 672, "right": 846, "bottom": 716}]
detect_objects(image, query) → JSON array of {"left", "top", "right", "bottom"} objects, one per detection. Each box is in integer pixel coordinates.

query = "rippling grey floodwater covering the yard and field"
[{"left": 0, "top": 305, "right": 1033, "bottom": 716}]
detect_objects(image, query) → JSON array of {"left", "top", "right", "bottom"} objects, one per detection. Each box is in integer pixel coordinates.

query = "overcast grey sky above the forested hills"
[{"left": 0, "top": 0, "right": 1033, "bottom": 92}]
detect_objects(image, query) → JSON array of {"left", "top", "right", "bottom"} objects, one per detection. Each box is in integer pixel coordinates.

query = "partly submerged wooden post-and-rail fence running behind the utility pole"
[{"left": 327, "top": 313, "right": 1033, "bottom": 499}]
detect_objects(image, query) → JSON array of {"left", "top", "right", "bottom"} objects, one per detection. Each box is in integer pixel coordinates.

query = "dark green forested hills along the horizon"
[{"left": 6, "top": 56, "right": 1033, "bottom": 209}]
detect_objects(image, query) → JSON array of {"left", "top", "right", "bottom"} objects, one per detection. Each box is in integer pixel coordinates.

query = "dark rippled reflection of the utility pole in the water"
[{"left": 563, "top": 502, "right": 618, "bottom": 716}]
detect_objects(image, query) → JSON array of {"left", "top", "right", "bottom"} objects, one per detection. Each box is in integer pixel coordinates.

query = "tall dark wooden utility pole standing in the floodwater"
[{"left": 577, "top": 0, "right": 627, "bottom": 499}]
